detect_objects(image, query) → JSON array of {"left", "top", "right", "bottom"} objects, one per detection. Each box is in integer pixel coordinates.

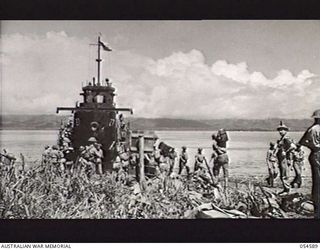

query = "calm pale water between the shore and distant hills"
[{"left": 0, "top": 130, "right": 310, "bottom": 176}]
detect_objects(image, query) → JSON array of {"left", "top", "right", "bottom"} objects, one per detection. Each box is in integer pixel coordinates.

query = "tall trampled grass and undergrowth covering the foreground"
[{"left": 0, "top": 156, "right": 311, "bottom": 219}]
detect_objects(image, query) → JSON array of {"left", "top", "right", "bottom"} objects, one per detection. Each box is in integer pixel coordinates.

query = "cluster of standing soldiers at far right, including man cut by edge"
[{"left": 266, "top": 109, "right": 320, "bottom": 219}]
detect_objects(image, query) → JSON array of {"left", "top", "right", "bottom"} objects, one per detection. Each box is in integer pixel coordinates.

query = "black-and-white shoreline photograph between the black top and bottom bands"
[{"left": 0, "top": 20, "right": 320, "bottom": 220}]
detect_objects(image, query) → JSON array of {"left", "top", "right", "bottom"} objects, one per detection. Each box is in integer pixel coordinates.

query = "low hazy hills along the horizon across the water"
[{"left": 0, "top": 115, "right": 312, "bottom": 131}]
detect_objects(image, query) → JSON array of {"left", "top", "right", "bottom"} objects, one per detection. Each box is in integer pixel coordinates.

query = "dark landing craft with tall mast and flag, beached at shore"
[{"left": 56, "top": 36, "right": 157, "bottom": 174}]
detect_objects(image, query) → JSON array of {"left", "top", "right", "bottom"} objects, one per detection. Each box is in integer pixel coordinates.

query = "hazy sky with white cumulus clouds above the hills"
[{"left": 1, "top": 20, "right": 320, "bottom": 119}]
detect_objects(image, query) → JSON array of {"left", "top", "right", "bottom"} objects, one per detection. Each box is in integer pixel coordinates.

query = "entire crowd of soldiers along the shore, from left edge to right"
[{"left": 0, "top": 110, "right": 320, "bottom": 218}]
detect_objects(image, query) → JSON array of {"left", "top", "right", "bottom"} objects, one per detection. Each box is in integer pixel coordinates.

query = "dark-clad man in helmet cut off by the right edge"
[{"left": 299, "top": 109, "right": 320, "bottom": 219}]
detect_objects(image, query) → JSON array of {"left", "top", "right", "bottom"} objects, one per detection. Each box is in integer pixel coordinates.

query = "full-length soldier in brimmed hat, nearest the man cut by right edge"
[{"left": 276, "top": 121, "right": 296, "bottom": 194}]
